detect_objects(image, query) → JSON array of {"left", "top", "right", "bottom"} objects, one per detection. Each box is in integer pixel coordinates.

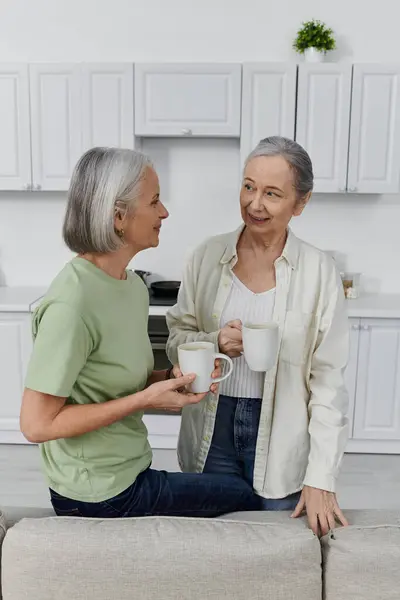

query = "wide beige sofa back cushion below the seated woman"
[{"left": 3, "top": 517, "right": 322, "bottom": 600}]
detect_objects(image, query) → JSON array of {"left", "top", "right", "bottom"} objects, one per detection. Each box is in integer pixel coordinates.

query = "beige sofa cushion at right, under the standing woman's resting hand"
[{"left": 322, "top": 510, "right": 400, "bottom": 600}]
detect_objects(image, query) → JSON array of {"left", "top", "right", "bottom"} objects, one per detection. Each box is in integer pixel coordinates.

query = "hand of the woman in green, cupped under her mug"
[{"left": 146, "top": 375, "right": 207, "bottom": 411}]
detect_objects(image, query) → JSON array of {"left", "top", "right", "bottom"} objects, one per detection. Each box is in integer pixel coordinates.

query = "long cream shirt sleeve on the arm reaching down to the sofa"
[{"left": 304, "top": 270, "right": 349, "bottom": 492}]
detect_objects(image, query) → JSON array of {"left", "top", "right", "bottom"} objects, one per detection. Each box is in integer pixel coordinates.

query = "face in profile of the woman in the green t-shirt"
[{"left": 116, "top": 167, "right": 169, "bottom": 251}]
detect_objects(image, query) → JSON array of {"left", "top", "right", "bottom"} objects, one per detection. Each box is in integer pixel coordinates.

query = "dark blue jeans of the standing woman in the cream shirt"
[{"left": 203, "top": 396, "right": 300, "bottom": 510}]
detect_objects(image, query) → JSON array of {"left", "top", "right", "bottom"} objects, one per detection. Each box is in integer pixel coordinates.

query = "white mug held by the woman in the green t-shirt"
[{"left": 178, "top": 342, "right": 233, "bottom": 394}]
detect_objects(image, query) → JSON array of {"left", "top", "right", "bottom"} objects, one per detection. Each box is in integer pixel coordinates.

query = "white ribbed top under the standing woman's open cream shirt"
[{"left": 220, "top": 273, "right": 275, "bottom": 398}]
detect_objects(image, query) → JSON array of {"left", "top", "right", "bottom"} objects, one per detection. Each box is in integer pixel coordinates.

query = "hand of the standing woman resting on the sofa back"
[{"left": 292, "top": 485, "right": 348, "bottom": 537}]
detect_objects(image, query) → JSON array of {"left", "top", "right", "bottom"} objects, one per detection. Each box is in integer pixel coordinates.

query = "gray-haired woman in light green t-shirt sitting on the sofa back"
[{"left": 21, "top": 148, "right": 257, "bottom": 518}]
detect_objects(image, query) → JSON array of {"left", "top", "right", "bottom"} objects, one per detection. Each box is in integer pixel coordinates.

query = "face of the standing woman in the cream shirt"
[{"left": 240, "top": 156, "right": 311, "bottom": 237}]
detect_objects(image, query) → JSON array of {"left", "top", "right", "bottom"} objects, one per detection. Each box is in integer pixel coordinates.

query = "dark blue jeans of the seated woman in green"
[{"left": 50, "top": 468, "right": 260, "bottom": 519}]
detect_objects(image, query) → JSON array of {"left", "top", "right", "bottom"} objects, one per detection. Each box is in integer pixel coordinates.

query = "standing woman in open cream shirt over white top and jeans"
[{"left": 167, "top": 137, "right": 348, "bottom": 534}]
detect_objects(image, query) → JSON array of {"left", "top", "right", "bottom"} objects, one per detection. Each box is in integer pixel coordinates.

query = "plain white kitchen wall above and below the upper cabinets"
[{"left": 0, "top": 0, "right": 400, "bottom": 293}]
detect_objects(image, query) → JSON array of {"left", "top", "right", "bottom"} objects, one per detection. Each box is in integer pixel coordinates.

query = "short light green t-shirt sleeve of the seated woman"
[{"left": 25, "top": 303, "right": 93, "bottom": 398}]
